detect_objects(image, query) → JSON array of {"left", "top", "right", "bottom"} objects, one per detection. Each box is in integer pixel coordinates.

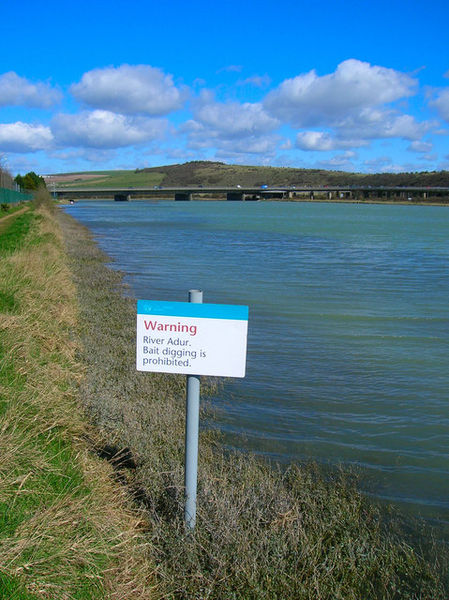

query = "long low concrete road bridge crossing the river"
[{"left": 50, "top": 185, "right": 449, "bottom": 202}]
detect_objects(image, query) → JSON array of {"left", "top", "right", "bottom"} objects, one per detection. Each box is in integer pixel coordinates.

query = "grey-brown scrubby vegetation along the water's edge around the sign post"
[{"left": 59, "top": 205, "right": 448, "bottom": 600}]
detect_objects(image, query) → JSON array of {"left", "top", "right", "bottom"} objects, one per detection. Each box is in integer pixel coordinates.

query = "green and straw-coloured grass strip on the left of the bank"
[{"left": 0, "top": 203, "right": 152, "bottom": 600}]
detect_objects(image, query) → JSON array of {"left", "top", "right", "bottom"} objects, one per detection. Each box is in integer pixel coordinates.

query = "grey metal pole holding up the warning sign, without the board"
[{"left": 184, "top": 290, "right": 203, "bottom": 530}]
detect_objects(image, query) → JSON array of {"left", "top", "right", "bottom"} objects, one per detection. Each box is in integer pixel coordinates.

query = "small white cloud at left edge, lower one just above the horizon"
[{"left": 0, "top": 121, "right": 53, "bottom": 153}]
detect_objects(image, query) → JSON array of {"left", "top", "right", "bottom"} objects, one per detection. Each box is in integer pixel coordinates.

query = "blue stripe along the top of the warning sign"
[{"left": 137, "top": 300, "right": 248, "bottom": 321}]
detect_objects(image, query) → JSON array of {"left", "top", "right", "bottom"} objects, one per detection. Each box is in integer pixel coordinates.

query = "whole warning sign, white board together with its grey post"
[{"left": 136, "top": 290, "right": 248, "bottom": 530}]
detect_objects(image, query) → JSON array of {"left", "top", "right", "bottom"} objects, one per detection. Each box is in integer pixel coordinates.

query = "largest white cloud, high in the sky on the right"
[{"left": 264, "top": 59, "right": 417, "bottom": 127}]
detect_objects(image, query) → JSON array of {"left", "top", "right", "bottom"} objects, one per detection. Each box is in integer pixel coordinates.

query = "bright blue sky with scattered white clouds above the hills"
[{"left": 0, "top": 0, "right": 449, "bottom": 174}]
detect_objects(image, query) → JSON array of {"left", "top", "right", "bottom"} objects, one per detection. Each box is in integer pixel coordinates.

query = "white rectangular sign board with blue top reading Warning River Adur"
[{"left": 137, "top": 300, "right": 248, "bottom": 377}]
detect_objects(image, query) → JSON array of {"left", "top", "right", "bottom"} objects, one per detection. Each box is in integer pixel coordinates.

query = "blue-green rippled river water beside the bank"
[{"left": 66, "top": 201, "right": 449, "bottom": 522}]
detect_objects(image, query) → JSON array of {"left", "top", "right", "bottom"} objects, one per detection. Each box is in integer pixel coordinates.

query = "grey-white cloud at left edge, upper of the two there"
[{"left": 0, "top": 71, "right": 62, "bottom": 108}]
